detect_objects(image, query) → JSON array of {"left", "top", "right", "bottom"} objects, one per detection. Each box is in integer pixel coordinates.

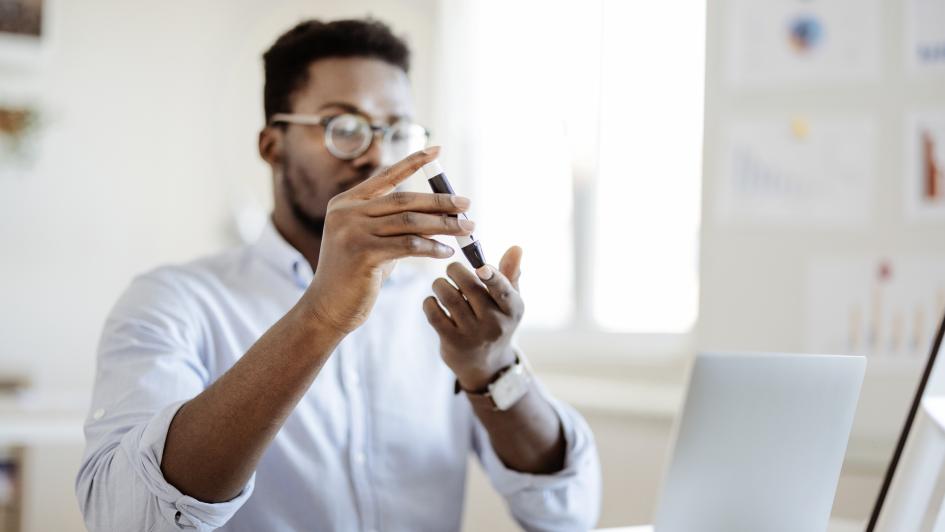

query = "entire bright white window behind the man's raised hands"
[{"left": 435, "top": 0, "right": 705, "bottom": 334}]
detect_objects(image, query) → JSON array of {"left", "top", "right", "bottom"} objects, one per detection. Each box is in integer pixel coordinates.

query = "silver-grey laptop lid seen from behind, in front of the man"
[{"left": 655, "top": 353, "right": 866, "bottom": 532}]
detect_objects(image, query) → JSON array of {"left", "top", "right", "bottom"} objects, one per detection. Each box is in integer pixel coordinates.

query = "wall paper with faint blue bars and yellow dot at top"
[{"left": 716, "top": 115, "right": 876, "bottom": 227}]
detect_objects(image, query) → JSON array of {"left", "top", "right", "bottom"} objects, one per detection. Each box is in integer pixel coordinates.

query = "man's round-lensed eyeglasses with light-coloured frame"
[{"left": 269, "top": 113, "right": 430, "bottom": 161}]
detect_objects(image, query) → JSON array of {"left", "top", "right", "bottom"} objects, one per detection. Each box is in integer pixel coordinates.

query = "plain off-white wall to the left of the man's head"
[{"left": 0, "top": 0, "right": 434, "bottom": 390}]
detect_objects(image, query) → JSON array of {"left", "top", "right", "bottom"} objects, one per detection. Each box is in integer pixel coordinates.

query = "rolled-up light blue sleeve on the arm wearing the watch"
[{"left": 473, "top": 383, "right": 601, "bottom": 532}]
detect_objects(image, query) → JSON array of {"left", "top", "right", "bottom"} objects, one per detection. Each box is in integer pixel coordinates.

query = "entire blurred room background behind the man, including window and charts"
[{"left": 0, "top": 0, "right": 945, "bottom": 531}]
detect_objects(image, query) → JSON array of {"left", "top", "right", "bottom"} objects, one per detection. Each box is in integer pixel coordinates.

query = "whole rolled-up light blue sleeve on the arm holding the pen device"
[{"left": 76, "top": 270, "right": 255, "bottom": 532}]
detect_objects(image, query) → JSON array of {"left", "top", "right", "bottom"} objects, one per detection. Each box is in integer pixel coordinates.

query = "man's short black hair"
[{"left": 263, "top": 18, "right": 410, "bottom": 123}]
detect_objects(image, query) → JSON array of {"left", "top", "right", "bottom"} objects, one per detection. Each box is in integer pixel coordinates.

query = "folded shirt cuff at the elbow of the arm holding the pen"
[{"left": 121, "top": 401, "right": 256, "bottom": 532}]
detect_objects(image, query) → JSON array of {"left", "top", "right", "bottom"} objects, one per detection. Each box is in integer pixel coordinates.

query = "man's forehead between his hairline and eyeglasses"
[{"left": 292, "top": 57, "right": 413, "bottom": 119}]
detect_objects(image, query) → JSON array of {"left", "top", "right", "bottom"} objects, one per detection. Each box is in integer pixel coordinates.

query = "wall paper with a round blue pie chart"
[{"left": 726, "top": 0, "right": 883, "bottom": 87}]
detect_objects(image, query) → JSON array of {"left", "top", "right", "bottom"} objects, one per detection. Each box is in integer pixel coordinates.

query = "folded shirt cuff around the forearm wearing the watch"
[{"left": 476, "top": 381, "right": 598, "bottom": 496}]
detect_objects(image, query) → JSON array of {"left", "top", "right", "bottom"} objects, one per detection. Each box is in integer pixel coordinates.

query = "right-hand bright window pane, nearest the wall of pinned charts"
[{"left": 591, "top": 0, "right": 705, "bottom": 333}]
